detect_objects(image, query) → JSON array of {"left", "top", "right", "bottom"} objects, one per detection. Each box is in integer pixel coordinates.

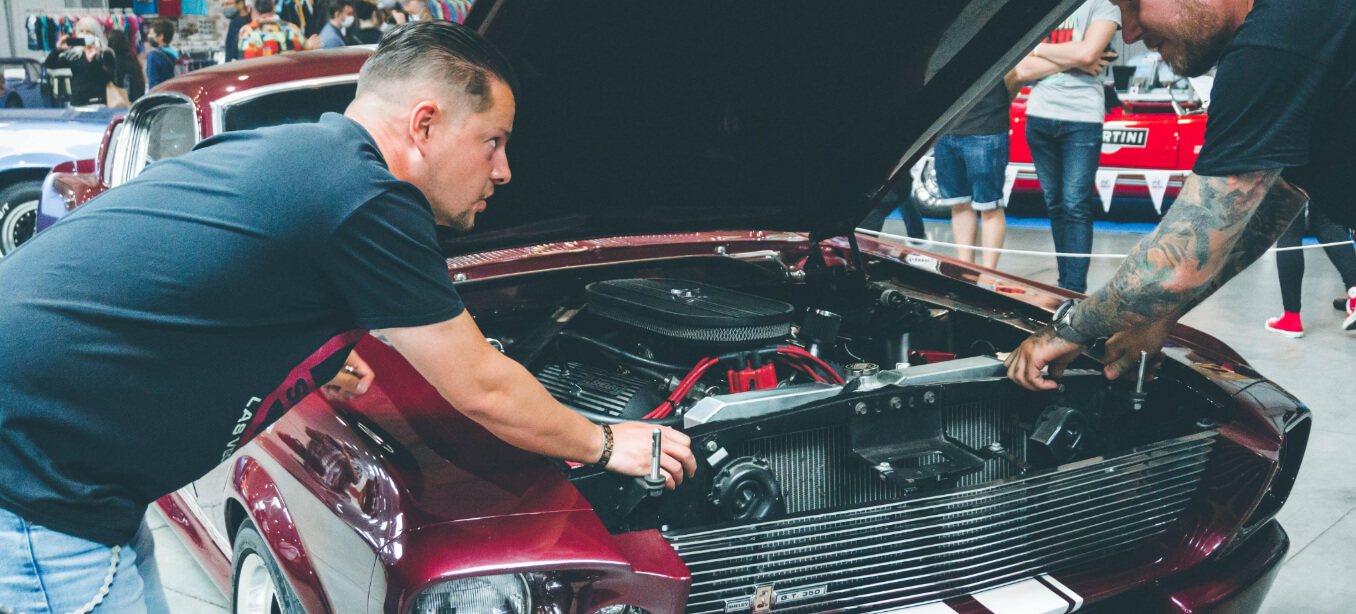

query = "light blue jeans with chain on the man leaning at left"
[{"left": 0, "top": 508, "right": 170, "bottom": 614}]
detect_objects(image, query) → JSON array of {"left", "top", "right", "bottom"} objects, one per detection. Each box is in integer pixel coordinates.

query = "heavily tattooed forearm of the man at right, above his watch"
[{"left": 1074, "top": 171, "right": 1294, "bottom": 337}]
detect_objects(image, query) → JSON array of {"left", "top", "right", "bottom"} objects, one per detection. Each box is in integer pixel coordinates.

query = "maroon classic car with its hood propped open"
[{"left": 43, "top": 0, "right": 1311, "bottom": 614}]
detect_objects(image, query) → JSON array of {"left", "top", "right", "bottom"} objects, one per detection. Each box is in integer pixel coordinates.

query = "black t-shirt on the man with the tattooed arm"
[{"left": 1195, "top": 0, "right": 1356, "bottom": 225}]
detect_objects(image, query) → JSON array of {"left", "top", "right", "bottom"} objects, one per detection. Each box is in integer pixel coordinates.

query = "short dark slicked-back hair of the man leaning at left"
[{"left": 358, "top": 20, "right": 518, "bottom": 112}]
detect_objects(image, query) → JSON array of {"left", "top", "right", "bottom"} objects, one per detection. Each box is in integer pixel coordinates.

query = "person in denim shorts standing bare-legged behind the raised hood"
[{"left": 933, "top": 80, "right": 1012, "bottom": 268}]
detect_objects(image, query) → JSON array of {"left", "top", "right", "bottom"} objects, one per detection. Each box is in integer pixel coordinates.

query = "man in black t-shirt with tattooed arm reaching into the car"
[{"left": 1008, "top": 0, "right": 1356, "bottom": 390}]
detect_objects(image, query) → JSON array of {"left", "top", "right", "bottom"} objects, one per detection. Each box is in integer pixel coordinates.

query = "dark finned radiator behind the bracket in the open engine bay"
[{"left": 731, "top": 398, "right": 1026, "bottom": 514}]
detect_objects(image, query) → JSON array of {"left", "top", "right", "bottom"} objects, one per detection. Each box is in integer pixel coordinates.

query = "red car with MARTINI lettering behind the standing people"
[{"left": 913, "top": 52, "right": 1211, "bottom": 218}]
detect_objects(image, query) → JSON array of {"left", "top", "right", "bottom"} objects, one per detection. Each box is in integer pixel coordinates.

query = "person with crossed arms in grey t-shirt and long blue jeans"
[{"left": 1017, "top": 0, "right": 1120, "bottom": 293}]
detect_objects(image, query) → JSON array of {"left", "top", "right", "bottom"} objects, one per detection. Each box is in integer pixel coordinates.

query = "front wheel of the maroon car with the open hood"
[{"left": 231, "top": 520, "right": 306, "bottom": 614}]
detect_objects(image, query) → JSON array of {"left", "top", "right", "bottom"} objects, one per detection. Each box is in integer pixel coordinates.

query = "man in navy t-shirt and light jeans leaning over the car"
[{"left": 0, "top": 22, "right": 696, "bottom": 613}]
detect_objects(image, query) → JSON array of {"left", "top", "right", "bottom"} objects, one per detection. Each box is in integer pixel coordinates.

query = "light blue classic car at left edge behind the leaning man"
[{"left": 0, "top": 108, "right": 126, "bottom": 256}]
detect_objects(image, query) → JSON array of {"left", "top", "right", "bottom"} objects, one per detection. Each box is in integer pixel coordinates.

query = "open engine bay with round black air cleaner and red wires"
[{"left": 468, "top": 256, "right": 1214, "bottom": 533}]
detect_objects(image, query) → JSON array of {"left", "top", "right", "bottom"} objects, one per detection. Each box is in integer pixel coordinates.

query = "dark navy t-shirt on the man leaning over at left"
[{"left": 0, "top": 114, "right": 464, "bottom": 544}]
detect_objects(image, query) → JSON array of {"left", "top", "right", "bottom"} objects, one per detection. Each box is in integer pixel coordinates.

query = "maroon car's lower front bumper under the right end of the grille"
[{"left": 1079, "top": 520, "right": 1290, "bottom": 614}]
